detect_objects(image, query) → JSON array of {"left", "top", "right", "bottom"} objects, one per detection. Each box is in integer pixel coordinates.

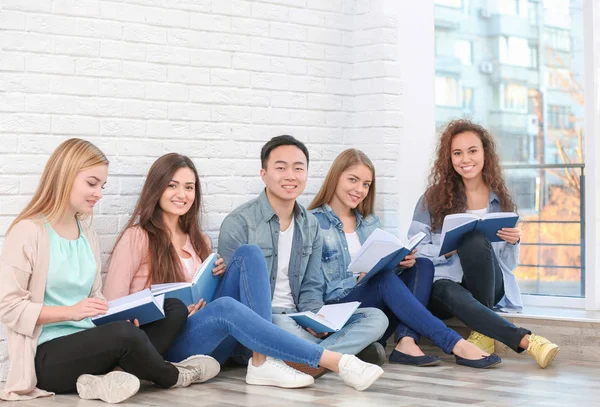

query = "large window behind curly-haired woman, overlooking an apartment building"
[{"left": 436, "top": 0, "right": 584, "bottom": 304}]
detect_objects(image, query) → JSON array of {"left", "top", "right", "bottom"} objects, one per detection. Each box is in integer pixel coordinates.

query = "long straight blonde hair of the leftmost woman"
[{"left": 8, "top": 138, "right": 108, "bottom": 231}]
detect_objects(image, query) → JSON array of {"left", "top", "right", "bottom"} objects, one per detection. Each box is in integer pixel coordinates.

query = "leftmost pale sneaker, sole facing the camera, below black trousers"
[{"left": 77, "top": 372, "right": 140, "bottom": 403}]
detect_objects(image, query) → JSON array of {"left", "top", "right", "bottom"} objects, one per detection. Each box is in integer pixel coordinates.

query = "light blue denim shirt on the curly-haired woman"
[{"left": 408, "top": 191, "right": 523, "bottom": 312}]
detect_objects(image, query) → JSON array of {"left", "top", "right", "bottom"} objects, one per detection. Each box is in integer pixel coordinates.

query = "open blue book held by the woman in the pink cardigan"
[{"left": 150, "top": 253, "right": 219, "bottom": 305}]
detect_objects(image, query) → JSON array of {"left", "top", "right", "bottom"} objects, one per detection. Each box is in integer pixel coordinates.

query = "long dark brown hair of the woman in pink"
[{"left": 115, "top": 153, "right": 211, "bottom": 284}]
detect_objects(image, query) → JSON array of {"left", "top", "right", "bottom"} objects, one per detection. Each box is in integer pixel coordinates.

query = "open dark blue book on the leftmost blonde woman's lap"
[{"left": 92, "top": 288, "right": 165, "bottom": 326}]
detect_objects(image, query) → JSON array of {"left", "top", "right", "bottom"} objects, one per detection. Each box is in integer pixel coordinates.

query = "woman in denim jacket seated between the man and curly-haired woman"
[{"left": 309, "top": 149, "right": 500, "bottom": 368}]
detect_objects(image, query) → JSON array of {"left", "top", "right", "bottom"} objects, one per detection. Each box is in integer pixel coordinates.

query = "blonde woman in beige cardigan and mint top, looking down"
[{"left": 0, "top": 139, "right": 219, "bottom": 403}]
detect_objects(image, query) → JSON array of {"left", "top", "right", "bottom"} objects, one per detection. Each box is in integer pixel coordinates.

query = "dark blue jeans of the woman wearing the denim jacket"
[{"left": 333, "top": 259, "right": 462, "bottom": 354}]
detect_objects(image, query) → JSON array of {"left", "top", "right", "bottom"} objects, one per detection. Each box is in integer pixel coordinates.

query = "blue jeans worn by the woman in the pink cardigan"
[{"left": 165, "top": 245, "right": 323, "bottom": 367}]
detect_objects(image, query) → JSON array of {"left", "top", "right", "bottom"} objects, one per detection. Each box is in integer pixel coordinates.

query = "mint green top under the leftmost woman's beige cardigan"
[{"left": 38, "top": 223, "right": 96, "bottom": 346}]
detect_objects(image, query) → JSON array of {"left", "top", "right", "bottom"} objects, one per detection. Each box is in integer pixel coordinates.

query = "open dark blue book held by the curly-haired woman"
[{"left": 439, "top": 212, "right": 519, "bottom": 256}]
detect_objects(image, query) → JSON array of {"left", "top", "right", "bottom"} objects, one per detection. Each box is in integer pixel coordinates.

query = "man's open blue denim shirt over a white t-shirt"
[{"left": 218, "top": 190, "right": 324, "bottom": 313}]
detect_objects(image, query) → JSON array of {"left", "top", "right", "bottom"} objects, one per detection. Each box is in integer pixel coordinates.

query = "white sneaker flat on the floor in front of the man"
[{"left": 246, "top": 356, "right": 315, "bottom": 389}]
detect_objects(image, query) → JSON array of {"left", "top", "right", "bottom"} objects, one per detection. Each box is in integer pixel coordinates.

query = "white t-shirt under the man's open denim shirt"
[{"left": 272, "top": 219, "right": 296, "bottom": 308}]
